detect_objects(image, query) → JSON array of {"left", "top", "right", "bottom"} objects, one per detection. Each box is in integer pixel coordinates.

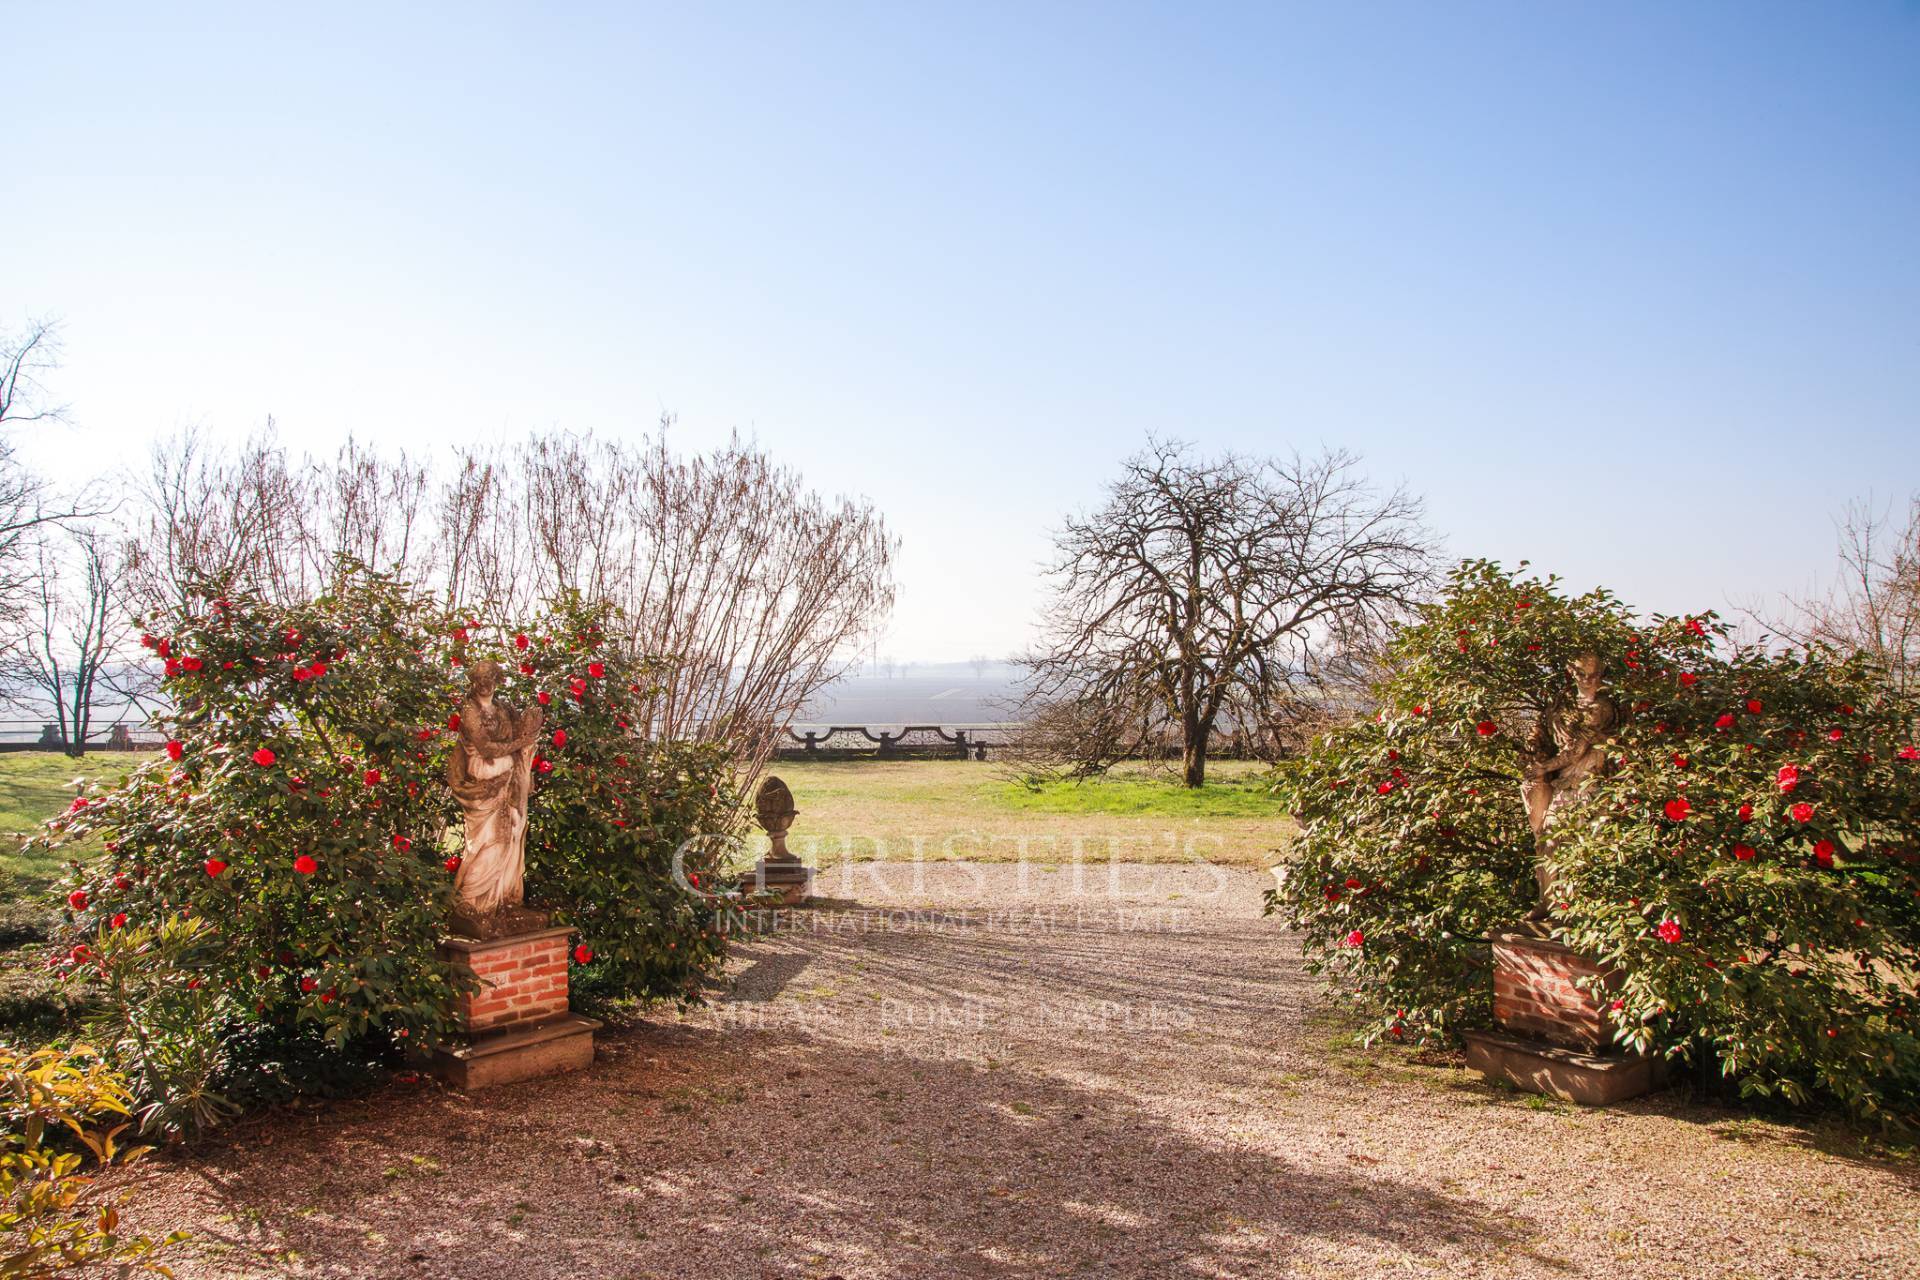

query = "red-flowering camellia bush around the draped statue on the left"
[{"left": 39, "top": 566, "right": 735, "bottom": 1132}]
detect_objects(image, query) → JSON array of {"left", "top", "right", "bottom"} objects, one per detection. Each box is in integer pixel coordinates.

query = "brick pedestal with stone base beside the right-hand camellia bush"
[{"left": 1467, "top": 931, "right": 1665, "bottom": 1105}]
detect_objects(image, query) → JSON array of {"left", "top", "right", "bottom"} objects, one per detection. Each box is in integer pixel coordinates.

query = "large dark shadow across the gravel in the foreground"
[{"left": 153, "top": 1025, "right": 1553, "bottom": 1280}]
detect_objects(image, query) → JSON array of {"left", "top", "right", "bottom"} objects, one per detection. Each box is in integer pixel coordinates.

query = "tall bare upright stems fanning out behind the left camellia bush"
[{"left": 134, "top": 420, "right": 895, "bottom": 781}]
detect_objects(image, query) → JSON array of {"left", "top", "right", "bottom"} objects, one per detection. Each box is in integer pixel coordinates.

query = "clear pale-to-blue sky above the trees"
[{"left": 0, "top": 0, "right": 1920, "bottom": 660}]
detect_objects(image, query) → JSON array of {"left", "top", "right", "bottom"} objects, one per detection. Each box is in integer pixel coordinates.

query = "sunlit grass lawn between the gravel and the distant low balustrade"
[{"left": 772, "top": 760, "right": 1292, "bottom": 865}]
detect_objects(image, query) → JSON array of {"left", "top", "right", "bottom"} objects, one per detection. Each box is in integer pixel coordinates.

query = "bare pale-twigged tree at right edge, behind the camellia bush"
[{"left": 1749, "top": 493, "right": 1920, "bottom": 700}]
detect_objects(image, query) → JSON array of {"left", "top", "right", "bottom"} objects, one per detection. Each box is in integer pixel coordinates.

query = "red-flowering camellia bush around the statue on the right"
[{"left": 1267, "top": 562, "right": 1920, "bottom": 1123}]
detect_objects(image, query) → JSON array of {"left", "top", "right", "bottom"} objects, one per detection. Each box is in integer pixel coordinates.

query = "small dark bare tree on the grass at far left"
[{"left": 8, "top": 530, "right": 138, "bottom": 756}]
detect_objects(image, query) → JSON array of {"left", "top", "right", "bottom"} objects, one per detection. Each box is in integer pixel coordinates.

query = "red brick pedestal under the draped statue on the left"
[{"left": 434, "top": 929, "right": 599, "bottom": 1088}]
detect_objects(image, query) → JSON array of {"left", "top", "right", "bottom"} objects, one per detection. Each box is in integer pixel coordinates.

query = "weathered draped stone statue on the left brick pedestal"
[{"left": 447, "top": 662, "right": 545, "bottom": 936}]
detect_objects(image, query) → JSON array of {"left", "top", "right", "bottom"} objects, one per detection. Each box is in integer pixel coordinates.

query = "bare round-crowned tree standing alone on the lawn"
[{"left": 1025, "top": 441, "right": 1432, "bottom": 787}]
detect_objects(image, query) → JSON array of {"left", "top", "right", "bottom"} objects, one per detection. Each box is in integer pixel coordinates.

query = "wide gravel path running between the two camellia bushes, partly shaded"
[{"left": 127, "top": 865, "right": 1920, "bottom": 1280}]
